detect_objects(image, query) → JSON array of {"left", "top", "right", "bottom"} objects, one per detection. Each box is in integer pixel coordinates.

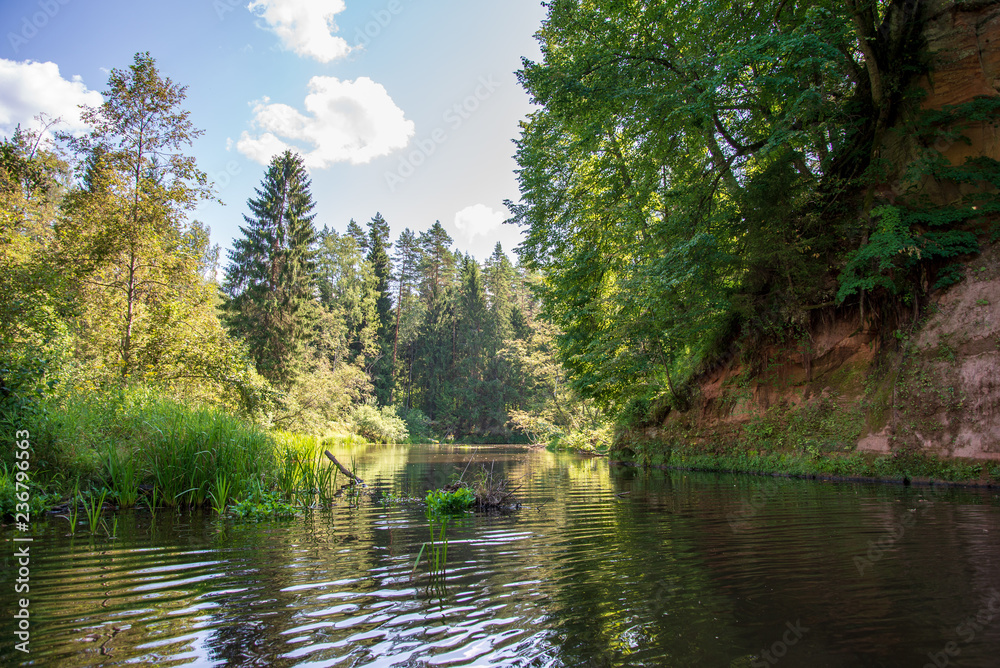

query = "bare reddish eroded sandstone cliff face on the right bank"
[{"left": 637, "top": 0, "right": 1000, "bottom": 460}]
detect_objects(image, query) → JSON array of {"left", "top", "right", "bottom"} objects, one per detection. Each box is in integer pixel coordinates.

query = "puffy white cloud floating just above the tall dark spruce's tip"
[{"left": 236, "top": 76, "right": 414, "bottom": 169}]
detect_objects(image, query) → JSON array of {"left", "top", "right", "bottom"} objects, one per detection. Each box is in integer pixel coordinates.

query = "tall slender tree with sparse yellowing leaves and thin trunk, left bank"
[{"left": 63, "top": 53, "right": 210, "bottom": 378}]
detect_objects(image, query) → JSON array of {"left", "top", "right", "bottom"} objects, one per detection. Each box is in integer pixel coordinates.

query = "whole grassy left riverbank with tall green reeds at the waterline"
[{"left": 0, "top": 387, "right": 363, "bottom": 517}]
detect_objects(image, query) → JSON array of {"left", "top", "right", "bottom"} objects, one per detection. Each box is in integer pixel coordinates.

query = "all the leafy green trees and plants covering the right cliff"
[{"left": 509, "top": 0, "right": 1000, "bottom": 452}]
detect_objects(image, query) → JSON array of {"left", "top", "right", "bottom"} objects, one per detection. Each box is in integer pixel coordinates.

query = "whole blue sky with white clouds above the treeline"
[{"left": 0, "top": 0, "right": 545, "bottom": 260}]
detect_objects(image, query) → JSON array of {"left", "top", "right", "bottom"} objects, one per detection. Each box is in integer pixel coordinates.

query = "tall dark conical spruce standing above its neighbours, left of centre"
[{"left": 223, "top": 151, "right": 316, "bottom": 387}]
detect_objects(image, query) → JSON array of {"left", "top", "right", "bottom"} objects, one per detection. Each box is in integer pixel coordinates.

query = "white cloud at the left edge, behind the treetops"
[{"left": 0, "top": 58, "right": 104, "bottom": 133}]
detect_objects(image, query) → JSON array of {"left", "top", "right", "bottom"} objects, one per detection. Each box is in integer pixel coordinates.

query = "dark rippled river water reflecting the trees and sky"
[{"left": 0, "top": 445, "right": 1000, "bottom": 668}]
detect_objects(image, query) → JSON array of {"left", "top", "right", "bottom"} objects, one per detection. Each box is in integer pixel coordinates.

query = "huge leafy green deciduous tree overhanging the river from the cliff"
[{"left": 508, "top": 0, "right": 932, "bottom": 418}]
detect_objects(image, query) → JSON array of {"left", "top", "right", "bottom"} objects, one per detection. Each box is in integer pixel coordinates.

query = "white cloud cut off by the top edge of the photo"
[{"left": 247, "top": 0, "right": 351, "bottom": 63}]
